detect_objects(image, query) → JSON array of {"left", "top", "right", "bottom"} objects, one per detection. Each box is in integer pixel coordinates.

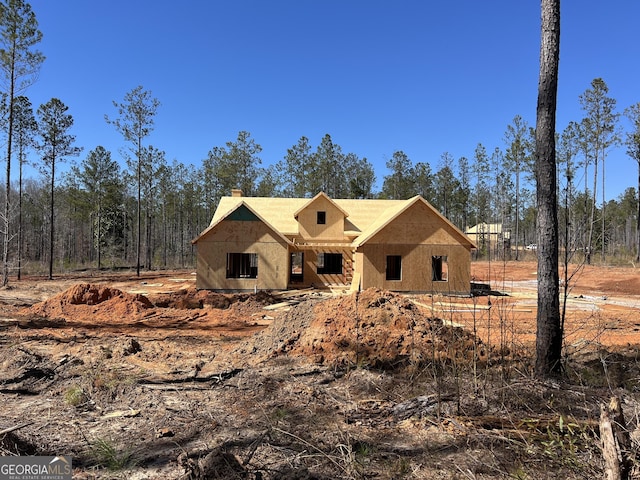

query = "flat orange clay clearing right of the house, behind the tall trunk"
[{"left": 468, "top": 261, "right": 640, "bottom": 348}]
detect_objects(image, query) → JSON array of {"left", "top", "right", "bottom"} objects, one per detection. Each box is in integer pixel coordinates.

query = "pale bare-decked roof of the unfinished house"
[{"left": 194, "top": 192, "right": 475, "bottom": 248}]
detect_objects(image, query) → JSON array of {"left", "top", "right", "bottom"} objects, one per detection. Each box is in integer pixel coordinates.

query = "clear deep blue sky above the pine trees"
[{"left": 26, "top": 0, "right": 640, "bottom": 198}]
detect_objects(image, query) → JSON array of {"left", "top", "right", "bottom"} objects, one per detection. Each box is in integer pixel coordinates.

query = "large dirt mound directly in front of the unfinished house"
[{"left": 237, "top": 289, "right": 485, "bottom": 368}]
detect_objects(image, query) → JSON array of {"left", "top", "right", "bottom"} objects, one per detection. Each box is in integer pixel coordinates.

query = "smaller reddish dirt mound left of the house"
[{"left": 20, "top": 283, "right": 153, "bottom": 320}]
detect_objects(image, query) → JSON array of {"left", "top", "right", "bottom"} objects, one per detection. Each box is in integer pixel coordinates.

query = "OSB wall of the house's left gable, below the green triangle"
[{"left": 196, "top": 220, "right": 289, "bottom": 290}]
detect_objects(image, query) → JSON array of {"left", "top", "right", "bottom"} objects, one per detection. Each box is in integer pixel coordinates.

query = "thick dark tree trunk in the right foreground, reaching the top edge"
[{"left": 535, "top": 0, "right": 562, "bottom": 377}]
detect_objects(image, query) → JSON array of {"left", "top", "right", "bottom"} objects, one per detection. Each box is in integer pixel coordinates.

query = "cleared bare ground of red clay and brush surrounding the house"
[{"left": 0, "top": 262, "right": 640, "bottom": 480}]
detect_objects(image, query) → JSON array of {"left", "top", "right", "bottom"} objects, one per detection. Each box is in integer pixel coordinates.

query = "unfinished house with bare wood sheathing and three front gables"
[{"left": 193, "top": 190, "right": 475, "bottom": 295}]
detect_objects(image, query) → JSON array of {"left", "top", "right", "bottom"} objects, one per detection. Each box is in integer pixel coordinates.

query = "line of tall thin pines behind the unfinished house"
[{"left": 0, "top": 0, "right": 640, "bottom": 284}]
